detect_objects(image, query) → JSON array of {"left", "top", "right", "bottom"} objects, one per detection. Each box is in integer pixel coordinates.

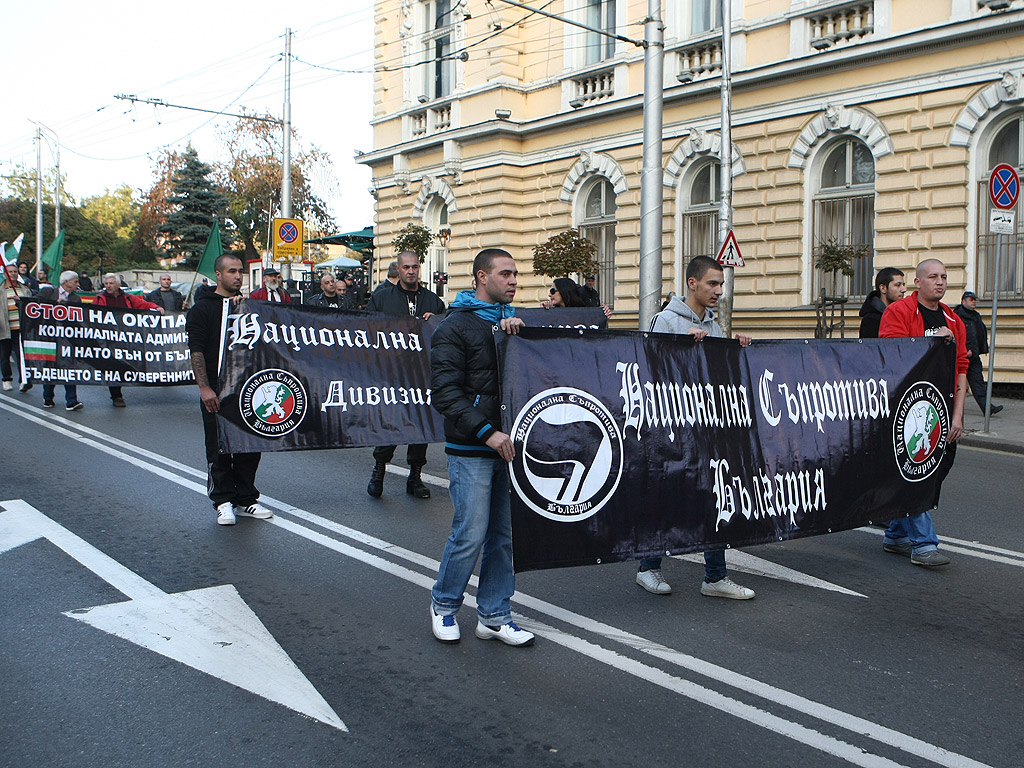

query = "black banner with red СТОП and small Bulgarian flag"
[{"left": 19, "top": 299, "right": 196, "bottom": 386}]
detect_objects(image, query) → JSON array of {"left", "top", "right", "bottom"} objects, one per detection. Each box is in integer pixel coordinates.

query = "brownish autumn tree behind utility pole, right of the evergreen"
[{"left": 217, "top": 110, "right": 335, "bottom": 259}]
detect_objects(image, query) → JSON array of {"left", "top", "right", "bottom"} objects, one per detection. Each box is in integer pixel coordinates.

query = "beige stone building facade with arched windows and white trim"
[{"left": 361, "top": 0, "right": 1024, "bottom": 383}]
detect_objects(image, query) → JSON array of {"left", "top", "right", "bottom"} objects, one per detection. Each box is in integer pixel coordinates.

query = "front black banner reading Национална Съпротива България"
[{"left": 500, "top": 328, "right": 953, "bottom": 571}]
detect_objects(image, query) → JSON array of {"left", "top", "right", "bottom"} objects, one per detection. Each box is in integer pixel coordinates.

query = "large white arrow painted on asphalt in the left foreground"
[{"left": 0, "top": 500, "right": 348, "bottom": 731}]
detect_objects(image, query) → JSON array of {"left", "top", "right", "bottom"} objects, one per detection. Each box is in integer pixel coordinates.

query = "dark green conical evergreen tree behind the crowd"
[{"left": 159, "top": 144, "right": 230, "bottom": 266}]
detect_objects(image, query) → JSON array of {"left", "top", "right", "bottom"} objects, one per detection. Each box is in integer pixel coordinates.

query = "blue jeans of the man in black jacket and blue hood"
[{"left": 430, "top": 456, "right": 515, "bottom": 627}]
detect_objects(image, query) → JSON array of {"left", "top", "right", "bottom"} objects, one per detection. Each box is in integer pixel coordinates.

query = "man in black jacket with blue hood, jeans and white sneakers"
[{"left": 430, "top": 248, "right": 534, "bottom": 646}]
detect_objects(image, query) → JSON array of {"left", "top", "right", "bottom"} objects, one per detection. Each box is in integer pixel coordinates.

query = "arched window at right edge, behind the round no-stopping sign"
[{"left": 975, "top": 115, "right": 1024, "bottom": 299}]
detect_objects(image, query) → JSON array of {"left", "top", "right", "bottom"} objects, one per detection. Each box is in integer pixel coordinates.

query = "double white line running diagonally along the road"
[{"left": 0, "top": 402, "right": 1001, "bottom": 768}]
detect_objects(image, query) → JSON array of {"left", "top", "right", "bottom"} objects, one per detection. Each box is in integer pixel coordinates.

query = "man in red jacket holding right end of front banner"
[{"left": 879, "top": 259, "right": 968, "bottom": 567}]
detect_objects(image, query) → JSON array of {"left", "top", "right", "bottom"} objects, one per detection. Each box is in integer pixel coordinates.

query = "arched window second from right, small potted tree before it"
[{"left": 811, "top": 136, "right": 874, "bottom": 299}]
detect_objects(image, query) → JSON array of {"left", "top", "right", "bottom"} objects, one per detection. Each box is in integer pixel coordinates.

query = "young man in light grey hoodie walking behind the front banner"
[{"left": 637, "top": 256, "right": 755, "bottom": 600}]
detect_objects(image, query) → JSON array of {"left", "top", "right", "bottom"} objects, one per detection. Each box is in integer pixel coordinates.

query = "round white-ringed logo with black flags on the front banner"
[{"left": 512, "top": 387, "right": 623, "bottom": 522}]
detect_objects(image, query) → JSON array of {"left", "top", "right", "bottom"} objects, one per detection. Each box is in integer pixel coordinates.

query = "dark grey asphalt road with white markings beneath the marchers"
[{"left": 0, "top": 387, "right": 1024, "bottom": 768}]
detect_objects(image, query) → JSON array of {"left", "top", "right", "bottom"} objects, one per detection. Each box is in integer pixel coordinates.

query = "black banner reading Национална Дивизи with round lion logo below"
[{"left": 218, "top": 301, "right": 444, "bottom": 454}]
